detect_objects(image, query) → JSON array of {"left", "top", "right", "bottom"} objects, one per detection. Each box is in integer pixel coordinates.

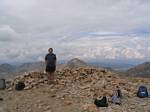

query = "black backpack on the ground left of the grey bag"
[{"left": 94, "top": 96, "right": 108, "bottom": 107}]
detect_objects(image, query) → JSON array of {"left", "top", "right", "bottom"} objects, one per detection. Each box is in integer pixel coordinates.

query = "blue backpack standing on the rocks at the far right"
[{"left": 137, "top": 86, "right": 148, "bottom": 98}]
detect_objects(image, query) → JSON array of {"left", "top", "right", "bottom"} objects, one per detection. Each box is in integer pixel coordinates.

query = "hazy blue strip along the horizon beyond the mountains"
[{"left": 0, "top": 58, "right": 144, "bottom": 70}]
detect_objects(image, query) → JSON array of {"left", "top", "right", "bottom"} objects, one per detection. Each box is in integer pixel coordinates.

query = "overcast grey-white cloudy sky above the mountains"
[{"left": 0, "top": 0, "right": 150, "bottom": 63}]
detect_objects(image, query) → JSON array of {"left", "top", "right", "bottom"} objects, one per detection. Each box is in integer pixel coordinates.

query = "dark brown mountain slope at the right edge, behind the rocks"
[{"left": 128, "top": 62, "right": 150, "bottom": 78}]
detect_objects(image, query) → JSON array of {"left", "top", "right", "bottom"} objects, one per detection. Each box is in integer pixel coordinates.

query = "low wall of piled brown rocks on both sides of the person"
[{"left": 10, "top": 68, "right": 146, "bottom": 98}]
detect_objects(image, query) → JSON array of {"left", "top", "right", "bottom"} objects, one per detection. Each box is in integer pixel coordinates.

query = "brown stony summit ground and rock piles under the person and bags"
[{"left": 0, "top": 67, "right": 150, "bottom": 112}]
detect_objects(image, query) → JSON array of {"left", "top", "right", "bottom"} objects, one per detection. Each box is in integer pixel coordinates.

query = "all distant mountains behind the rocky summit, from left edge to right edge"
[{"left": 0, "top": 58, "right": 150, "bottom": 78}]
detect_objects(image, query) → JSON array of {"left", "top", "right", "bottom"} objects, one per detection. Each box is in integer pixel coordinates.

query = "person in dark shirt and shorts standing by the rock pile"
[{"left": 45, "top": 48, "right": 56, "bottom": 82}]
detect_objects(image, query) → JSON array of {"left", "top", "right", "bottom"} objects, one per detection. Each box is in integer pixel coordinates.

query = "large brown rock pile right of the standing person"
[{"left": 53, "top": 68, "right": 136, "bottom": 98}]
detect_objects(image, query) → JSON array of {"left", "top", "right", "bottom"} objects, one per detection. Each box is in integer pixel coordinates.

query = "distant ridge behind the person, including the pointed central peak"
[{"left": 0, "top": 58, "right": 90, "bottom": 78}]
